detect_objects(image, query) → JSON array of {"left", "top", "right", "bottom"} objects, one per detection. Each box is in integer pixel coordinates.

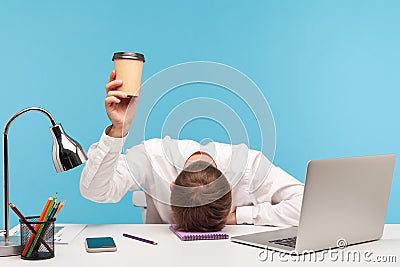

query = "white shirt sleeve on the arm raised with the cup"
[{"left": 80, "top": 129, "right": 147, "bottom": 202}]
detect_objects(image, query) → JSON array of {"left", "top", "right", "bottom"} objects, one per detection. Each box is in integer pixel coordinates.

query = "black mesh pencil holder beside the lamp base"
[{"left": 19, "top": 216, "right": 56, "bottom": 260}]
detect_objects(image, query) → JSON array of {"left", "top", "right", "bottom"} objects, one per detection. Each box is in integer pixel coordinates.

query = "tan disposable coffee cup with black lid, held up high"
[{"left": 112, "top": 52, "right": 145, "bottom": 96}]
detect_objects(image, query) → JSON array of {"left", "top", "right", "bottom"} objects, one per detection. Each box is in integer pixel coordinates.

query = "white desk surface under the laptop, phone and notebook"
[{"left": 0, "top": 224, "right": 400, "bottom": 267}]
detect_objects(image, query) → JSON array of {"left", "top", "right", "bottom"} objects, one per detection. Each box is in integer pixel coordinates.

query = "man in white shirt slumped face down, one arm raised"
[{"left": 80, "top": 71, "right": 303, "bottom": 231}]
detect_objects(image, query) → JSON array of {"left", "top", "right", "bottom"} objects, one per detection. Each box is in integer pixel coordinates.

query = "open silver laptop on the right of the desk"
[{"left": 231, "top": 154, "right": 396, "bottom": 253}]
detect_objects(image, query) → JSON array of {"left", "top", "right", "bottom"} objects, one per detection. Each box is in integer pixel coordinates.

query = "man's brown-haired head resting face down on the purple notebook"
[{"left": 171, "top": 161, "right": 232, "bottom": 231}]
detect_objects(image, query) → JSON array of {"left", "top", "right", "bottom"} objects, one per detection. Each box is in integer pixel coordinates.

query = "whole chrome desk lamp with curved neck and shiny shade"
[{"left": 0, "top": 107, "right": 87, "bottom": 256}]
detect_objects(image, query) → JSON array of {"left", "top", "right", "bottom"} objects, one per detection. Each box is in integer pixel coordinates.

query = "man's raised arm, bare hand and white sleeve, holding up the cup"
[{"left": 80, "top": 71, "right": 149, "bottom": 202}]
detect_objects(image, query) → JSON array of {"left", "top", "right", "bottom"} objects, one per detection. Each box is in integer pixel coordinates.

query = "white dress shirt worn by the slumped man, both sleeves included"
[{"left": 80, "top": 130, "right": 303, "bottom": 226}]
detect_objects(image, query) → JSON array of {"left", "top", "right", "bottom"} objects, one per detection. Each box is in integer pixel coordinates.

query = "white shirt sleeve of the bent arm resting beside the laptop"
[{"left": 236, "top": 152, "right": 304, "bottom": 226}]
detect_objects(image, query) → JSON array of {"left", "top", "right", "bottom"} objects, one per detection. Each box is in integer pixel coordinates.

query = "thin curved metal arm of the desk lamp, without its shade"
[{"left": 2, "top": 107, "right": 57, "bottom": 241}]
